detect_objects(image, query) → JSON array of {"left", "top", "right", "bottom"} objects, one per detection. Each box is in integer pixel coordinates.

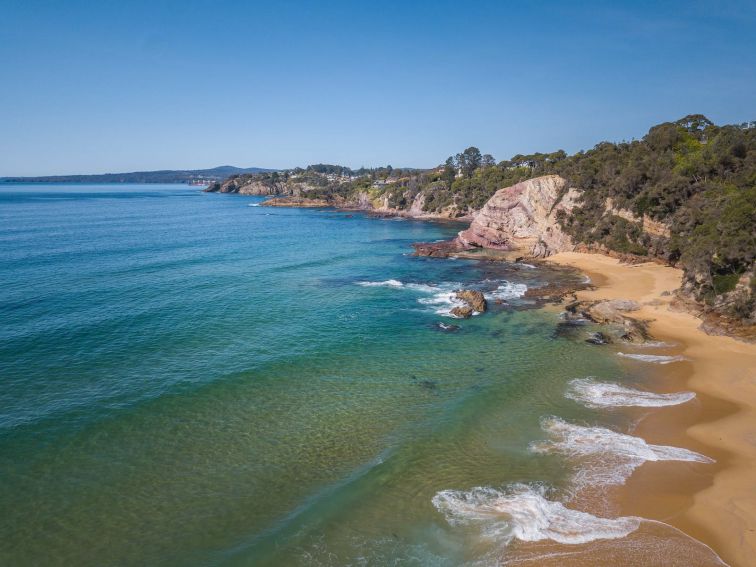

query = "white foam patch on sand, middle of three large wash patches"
[{"left": 530, "top": 417, "right": 715, "bottom": 488}]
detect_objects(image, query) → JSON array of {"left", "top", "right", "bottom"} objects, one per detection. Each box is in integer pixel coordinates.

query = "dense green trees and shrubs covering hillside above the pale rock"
[{"left": 426, "top": 114, "right": 756, "bottom": 318}]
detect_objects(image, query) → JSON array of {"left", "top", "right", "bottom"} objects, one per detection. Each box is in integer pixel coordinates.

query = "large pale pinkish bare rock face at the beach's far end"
[{"left": 457, "top": 175, "right": 579, "bottom": 258}]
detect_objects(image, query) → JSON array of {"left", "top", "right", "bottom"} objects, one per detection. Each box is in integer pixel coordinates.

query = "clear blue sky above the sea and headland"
[{"left": 0, "top": 0, "right": 756, "bottom": 176}]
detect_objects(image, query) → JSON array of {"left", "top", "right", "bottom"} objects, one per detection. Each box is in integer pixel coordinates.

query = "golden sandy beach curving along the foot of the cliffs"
[{"left": 548, "top": 252, "right": 756, "bottom": 566}]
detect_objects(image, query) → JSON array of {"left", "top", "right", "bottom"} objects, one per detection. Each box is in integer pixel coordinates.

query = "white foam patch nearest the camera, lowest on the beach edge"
[{"left": 433, "top": 484, "right": 642, "bottom": 544}]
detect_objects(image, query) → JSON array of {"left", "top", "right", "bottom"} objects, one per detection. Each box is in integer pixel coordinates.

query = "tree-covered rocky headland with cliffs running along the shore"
[{"left": 206, "top": 114, "right": 756, "bottom": 335}]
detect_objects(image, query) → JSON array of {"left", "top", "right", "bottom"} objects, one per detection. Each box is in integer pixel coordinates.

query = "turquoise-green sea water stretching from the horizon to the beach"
[{"left": 0, "top": 185, "right": 720, "bottom": 565}]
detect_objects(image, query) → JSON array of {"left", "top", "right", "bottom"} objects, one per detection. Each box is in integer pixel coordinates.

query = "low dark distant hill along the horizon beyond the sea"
[{"left": 0, "top": 165, "right": 275, "bottom": 183}]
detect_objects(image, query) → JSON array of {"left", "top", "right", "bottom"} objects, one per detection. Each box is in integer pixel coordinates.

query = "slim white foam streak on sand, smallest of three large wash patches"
[{"left": 565, "top": 378, "right": 696, "bottom": 408}]
